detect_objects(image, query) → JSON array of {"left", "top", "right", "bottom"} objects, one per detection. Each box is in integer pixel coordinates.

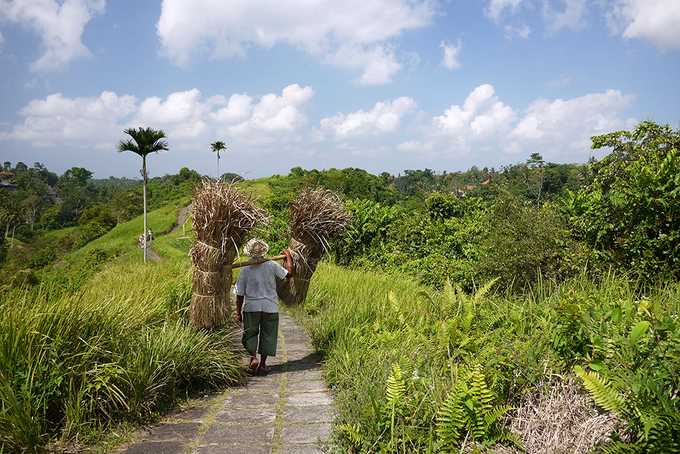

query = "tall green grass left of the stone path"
[{"left": 0, "top": 258, "right": 240, "bottom": 451}]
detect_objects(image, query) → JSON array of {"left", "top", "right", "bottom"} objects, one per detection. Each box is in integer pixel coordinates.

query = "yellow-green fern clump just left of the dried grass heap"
[{"left": 436, "top": 366, "right": 520, "bottom": 451}]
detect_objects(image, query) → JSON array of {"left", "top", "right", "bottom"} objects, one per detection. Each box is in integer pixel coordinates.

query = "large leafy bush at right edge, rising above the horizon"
[{"left": 566, "top": 122, "right": 680, "bottom": 279}]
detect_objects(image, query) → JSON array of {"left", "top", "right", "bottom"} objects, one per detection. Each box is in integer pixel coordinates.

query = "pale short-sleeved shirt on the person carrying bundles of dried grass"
[{"left": 236, "top": 261, "right": 288, "bottom": 313}]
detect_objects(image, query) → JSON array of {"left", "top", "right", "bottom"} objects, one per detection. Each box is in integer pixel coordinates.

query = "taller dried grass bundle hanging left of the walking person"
[{"left": 189, "top": 180, "right": 268, "bottom": 329}]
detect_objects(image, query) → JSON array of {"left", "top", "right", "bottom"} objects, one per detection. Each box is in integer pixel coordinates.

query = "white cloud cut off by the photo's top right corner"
[{"left": 607, "top": 0, "right": 680, "bottom": 50}]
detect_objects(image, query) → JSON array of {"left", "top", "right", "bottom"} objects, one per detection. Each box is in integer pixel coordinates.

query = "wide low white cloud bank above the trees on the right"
[{"left": 397, "top": 84, "right": 633, "bottom": 164}]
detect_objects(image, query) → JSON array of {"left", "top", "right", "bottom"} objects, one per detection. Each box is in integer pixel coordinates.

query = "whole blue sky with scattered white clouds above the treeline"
[{"left": 0, "top": 0, "right": 680, "bottom": 177}]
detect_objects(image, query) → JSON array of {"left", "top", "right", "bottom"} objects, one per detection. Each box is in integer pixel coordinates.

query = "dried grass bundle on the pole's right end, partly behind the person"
[{"left": 277, "top": 188, "right": 350, "bottom": 304}]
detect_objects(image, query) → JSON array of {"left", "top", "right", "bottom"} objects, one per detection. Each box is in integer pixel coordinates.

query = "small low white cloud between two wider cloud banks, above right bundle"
[{"left": 320, "top": 96, "right": 416, "bottom": 139}]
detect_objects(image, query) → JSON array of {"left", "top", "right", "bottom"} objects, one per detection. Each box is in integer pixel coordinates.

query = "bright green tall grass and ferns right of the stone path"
[{"left": 302, "top": 264, "right": 680, "bottom": 452}]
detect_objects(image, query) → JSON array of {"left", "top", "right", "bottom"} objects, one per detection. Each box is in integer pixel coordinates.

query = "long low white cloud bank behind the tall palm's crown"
[{"left": 0, "top": 84, "right": 314, "bottom": 150}]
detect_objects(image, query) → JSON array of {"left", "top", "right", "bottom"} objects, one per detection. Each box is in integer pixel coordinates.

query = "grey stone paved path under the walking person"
[{"left": 117, "top": 313, "right": 334, "bottom": 454}]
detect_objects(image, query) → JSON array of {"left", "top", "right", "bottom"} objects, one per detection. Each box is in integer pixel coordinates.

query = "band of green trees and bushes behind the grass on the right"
[{"left": 259, "top": 123, "right": 680, "bottom": 290}]
